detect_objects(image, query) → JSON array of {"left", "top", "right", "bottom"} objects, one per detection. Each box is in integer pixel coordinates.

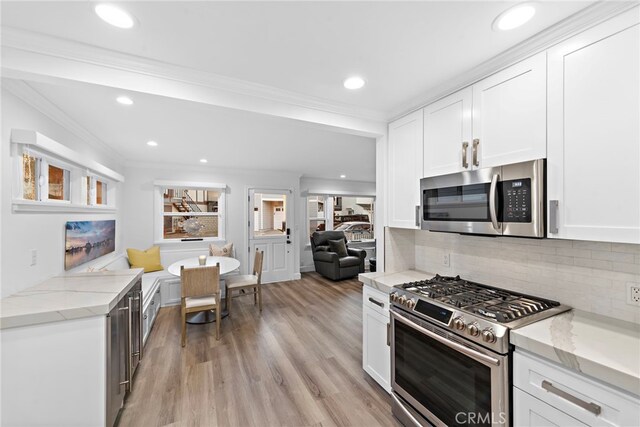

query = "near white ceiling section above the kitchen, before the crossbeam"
[{"left": 2, "top": 1, "right": 593, "bottom": 112}]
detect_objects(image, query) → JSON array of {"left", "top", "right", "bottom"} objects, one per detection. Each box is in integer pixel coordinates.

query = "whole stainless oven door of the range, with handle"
[{"left": 391, "top": 311, "right": 509, "bottom": 426}]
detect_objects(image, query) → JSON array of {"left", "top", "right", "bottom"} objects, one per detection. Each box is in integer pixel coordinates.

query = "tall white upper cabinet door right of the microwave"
[{"left": 547, "top": 8, "right": 640, "bottom": 243}]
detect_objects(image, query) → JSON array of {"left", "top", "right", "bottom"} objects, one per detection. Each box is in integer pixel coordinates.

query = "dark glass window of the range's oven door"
[{"left": 394, "top": 321, "right": 491, "bottom": 426}]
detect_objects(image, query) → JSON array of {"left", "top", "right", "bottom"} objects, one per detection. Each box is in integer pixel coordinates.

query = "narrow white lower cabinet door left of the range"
[{"left": 362, "top": 306, "right": 391, "bottom": 393}]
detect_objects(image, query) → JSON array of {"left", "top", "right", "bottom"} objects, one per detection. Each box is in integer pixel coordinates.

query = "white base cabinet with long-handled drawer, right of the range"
[{"left": 513, "top": 349, "right": 640, "bottom": 427}]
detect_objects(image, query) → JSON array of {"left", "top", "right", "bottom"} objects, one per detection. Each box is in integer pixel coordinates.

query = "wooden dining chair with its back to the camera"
[{"left": 180, "top": 264, "right": 221, "bottom": 347}]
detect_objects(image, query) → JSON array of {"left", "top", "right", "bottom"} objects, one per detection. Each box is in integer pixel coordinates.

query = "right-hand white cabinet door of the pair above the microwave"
[{"left": 471, "top": 52, "right": 547, "bottom": 168}]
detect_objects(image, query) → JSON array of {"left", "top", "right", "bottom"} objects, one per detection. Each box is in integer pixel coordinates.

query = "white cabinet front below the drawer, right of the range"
[{"left": 513, "top": 387, "right": 586, "bottom": 427}]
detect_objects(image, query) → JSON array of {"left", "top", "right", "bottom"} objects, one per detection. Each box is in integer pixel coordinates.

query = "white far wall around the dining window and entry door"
[{"left": 123, "top": 164, "right": 301, "bottom": 274}]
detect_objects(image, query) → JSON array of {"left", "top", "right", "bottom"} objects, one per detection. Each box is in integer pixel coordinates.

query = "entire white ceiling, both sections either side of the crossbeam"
[{"left": 1, "top": 1, "right": 594, "bottom": 181}]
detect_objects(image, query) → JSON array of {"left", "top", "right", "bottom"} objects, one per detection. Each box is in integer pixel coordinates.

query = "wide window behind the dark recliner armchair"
[{"left": 307, "top": 196, "right": 374, "bottom": 241}]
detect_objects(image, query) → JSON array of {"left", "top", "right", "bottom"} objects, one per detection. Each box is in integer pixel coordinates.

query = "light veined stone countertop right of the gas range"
[{"left": 511, "top": 310, "right": 640, "bottom": 396}]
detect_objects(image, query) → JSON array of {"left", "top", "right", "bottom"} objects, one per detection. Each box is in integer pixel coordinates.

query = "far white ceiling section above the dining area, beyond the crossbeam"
[{"left": 22, "top": 82, "right": 375, "bottom": 182}]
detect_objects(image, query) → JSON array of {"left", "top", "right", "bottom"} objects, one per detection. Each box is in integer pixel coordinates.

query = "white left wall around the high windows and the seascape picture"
[{"left": 0, "top": 88, "right": 123, "bottom": 297}]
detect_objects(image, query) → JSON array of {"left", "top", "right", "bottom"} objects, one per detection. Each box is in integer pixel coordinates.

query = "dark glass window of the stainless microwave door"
[{"left": 422, "top": 183, "right": 491, "bottom": 222}]
